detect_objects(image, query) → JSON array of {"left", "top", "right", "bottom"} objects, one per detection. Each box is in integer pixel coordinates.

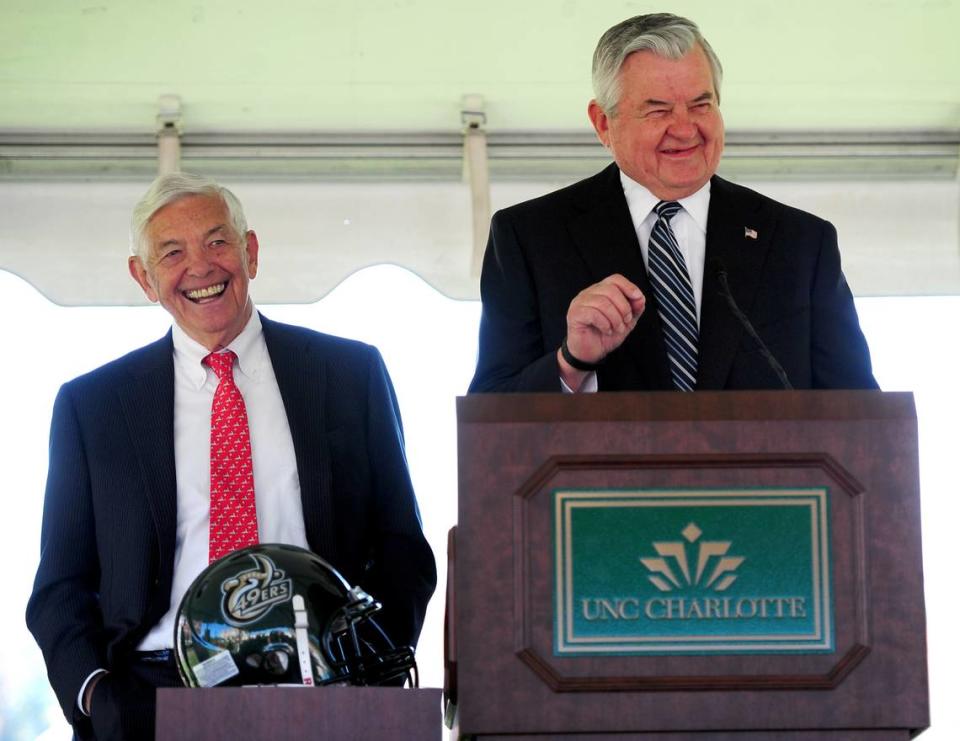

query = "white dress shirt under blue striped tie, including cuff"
[{"left": 560, "top": 170, "right": 710, "bottom": 394}]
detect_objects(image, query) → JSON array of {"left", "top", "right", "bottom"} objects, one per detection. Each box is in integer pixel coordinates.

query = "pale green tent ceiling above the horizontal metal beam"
[{"left": 0, "top": 0, "right": 960, "bottom": 132}]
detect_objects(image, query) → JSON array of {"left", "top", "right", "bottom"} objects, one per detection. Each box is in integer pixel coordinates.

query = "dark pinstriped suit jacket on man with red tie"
[{"left": 27, "top": 318, "right": 436, "bottom": 722}]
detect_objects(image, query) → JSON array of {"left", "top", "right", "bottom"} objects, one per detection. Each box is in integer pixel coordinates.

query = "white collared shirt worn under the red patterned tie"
[{"left": 137, "top": 309, "right": 307, "bottom": 651}]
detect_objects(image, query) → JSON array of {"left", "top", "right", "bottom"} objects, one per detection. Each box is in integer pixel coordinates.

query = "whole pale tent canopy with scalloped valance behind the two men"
[{"left": 0, "top": 0, "right": 960, "bottom": 303}]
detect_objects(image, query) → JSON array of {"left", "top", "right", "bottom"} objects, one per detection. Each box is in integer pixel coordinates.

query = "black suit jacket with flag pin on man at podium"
[{"left": 470, "top": 165, "right": 877, "bottom": 392}]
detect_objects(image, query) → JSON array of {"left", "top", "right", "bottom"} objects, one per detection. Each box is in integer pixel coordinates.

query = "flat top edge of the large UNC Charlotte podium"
[{"left": 457, "top": 390, "right": 917, "bottom": 424}]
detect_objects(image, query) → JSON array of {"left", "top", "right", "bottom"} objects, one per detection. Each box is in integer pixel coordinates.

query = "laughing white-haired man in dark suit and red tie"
[{"left": 27, "top": 174, "right": 436, "bottom": 739}]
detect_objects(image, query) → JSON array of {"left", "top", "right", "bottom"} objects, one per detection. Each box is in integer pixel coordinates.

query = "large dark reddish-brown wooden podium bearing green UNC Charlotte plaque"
[{"left": 446, "top": 391, "right": 929, "bottom": 741}]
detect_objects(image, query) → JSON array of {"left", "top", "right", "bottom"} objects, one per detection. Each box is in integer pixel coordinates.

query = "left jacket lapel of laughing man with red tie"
[{"left": 117, "top": 332, "right": 177, "bottom": 574}]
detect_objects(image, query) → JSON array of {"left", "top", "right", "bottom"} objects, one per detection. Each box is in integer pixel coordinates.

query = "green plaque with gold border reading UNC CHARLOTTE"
[{"left": 553, "top": 488, "right": 834, "bottom": 656}]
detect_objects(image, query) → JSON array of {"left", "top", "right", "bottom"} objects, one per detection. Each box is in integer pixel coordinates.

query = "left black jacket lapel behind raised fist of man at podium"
[{"left": 569, "top": 164, "right": 672, "bottom": 389}]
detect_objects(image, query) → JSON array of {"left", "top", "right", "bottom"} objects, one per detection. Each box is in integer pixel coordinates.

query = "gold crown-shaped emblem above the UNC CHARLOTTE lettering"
[{"left": 640, "top": 522, "right": 745, "bottom": 592}]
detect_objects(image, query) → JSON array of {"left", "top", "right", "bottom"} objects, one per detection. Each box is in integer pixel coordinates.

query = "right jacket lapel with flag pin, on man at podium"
[{"left": 697, "top": 177, "right": 775, "bottom": 389}]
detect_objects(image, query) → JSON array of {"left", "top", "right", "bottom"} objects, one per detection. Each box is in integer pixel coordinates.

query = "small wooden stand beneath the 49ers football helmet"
[{"left": 156, "top": 687, "right": 441, "bottom": 741}]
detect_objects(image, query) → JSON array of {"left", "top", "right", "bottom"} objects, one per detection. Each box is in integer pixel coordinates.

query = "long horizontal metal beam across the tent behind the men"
[{"left": 0, "top": 129, "right": 960, "bottom": 181}]
